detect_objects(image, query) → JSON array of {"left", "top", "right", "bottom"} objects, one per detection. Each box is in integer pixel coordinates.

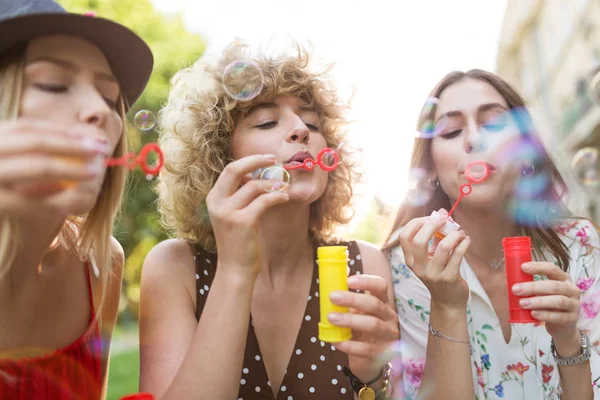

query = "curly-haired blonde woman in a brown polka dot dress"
[{"left": 140, "top": 38, "right": 399, "bottom": 400}]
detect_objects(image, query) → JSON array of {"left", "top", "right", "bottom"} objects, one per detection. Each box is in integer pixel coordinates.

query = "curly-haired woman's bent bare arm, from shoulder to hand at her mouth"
[{"left": 140, "top": 154, "right": 289, "bottom": 400}]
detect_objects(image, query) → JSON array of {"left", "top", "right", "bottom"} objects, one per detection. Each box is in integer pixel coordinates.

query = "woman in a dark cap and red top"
[{"left": 0, "top": 0, "right": 152, "bottom": 399}]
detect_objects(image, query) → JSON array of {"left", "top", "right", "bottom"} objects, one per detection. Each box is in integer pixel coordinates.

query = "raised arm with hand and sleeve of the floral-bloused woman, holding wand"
[{"left": 391, "top": 217, "right": 475, "bottom": 400}]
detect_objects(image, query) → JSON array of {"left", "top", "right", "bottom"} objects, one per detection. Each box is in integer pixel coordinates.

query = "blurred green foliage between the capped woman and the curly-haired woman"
[{"left": 58, "top": 0, "right": 206, "bottom": 320}]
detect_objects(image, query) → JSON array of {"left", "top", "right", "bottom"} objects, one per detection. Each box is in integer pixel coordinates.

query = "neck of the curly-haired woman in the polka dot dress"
[{"left": 259, "top": 204, "right": 313, "bottom": 286}]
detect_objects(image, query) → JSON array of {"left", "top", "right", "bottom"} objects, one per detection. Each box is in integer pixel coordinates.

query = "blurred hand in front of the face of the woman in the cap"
[{"left": 0, "top": 119, "right": 112, "bottom": 215}]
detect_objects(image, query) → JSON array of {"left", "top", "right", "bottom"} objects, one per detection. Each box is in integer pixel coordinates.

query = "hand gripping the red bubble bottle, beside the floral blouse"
[{"left": 512, "top": 262, "right": 581, "bottom": 346}]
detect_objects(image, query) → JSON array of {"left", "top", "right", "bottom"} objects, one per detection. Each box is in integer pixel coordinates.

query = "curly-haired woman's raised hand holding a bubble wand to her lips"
[{"left": 206, "top": 154, "right": 289, "bottom": 274}]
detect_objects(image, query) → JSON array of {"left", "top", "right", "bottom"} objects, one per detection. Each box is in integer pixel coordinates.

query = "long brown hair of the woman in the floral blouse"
[{"left": 384, "top": 69, "right": 570, "bottom": 271}]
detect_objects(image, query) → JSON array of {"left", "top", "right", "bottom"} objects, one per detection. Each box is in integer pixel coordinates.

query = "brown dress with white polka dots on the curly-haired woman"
[{"left": 195, "top": 242, "right": 363, "bottom": 400}]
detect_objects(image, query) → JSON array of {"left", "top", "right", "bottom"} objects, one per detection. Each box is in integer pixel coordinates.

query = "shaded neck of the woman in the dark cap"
[{"left": 0, "top": 215, "right": 65, "bottom": 293}]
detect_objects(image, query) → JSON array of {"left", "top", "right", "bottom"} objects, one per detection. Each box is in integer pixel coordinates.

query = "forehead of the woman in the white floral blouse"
[{"left": 435, "top": 78, "right": 508, "bottom": 118}]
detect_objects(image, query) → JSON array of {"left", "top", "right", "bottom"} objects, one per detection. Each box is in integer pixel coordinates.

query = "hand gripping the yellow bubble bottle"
[{"left": 328, "top": 274, "right": 400, "bottom": 383}]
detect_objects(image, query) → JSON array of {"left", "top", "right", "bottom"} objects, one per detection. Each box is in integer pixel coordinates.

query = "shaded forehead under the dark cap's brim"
[{"left": 25, "top": 35, "right": 112, "bottom": 74}]
